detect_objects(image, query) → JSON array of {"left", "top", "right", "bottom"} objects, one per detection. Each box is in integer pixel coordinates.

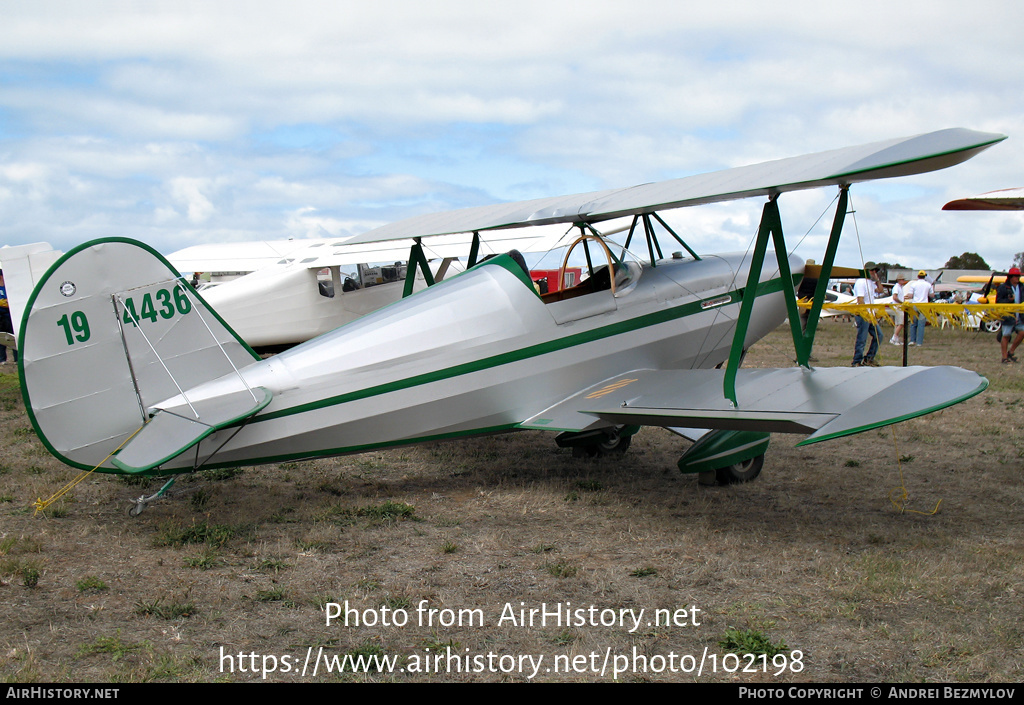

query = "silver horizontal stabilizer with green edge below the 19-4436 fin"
[{"left": 113, "top": 387, "right": 272, "bottom": 472}]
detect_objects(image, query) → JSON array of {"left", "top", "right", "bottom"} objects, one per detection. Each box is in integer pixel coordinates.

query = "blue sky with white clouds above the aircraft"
[{"left": 0, "top": 0, "right": 1024, "bottom": 268}]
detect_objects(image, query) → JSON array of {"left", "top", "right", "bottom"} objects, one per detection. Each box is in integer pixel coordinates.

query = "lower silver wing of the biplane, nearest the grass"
[{"left": 521, "top": 367, "right": 988, "bottom": 444}]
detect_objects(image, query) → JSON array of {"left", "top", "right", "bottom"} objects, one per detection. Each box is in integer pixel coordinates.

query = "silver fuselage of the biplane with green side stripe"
[{"left": 156, "top": 254, "right": 802, "bottom": 469}]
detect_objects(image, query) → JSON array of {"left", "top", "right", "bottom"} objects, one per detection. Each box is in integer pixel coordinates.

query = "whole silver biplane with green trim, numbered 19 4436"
[{"left": 19, "top": 129, "right": 1005, "bottom": 513}]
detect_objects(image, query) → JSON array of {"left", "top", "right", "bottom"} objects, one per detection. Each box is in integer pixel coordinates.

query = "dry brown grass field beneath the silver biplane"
[{"left": 0, "top": 321, "right": 1024, "bottom": 683}]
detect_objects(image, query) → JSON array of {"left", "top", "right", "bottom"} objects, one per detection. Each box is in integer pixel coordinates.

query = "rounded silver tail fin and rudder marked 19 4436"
[{"left": 18, "top": 238, "right": 259, "bottom": 471}]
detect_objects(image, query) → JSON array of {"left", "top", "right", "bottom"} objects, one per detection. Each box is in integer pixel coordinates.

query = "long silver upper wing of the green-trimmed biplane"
[{"left": 348, "top": 128, "right": 1006, "bottom": 244}]
